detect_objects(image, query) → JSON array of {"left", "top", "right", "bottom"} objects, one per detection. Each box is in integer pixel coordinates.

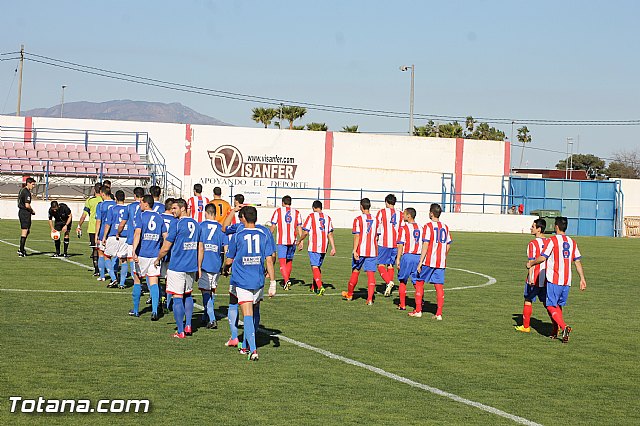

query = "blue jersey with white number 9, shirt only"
[{"left": 167, "top": 217, "right": 198, "bottom": 272}]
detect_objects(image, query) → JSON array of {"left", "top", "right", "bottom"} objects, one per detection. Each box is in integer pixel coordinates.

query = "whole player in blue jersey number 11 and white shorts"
[{"left": 224, "top": 206, "right": 276, "bottom": 361}]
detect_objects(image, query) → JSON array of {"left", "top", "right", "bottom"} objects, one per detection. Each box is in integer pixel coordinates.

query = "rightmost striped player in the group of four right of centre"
[{"left": 416, "top": 203, "right": 451, "bottom": 320}]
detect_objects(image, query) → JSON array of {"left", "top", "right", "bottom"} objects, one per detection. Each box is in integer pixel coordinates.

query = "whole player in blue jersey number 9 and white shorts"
[{"left": 155, "top": 198, "right": 198, "bottom": 339}]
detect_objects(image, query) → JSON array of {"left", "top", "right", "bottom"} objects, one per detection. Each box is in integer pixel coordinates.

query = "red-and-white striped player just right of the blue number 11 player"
[{"left": 270, "top": 195, "right": 302, "bottom": 290}]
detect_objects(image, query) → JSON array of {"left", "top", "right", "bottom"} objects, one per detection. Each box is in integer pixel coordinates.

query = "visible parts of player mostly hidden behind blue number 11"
[{"left": 222, "top": 202, "right": 276, "bottom": 348}]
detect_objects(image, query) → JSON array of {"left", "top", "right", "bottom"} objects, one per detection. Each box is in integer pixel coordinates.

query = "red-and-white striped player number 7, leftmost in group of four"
[{"left": 342, "top": 198, "right": 378, "bottom": 305}]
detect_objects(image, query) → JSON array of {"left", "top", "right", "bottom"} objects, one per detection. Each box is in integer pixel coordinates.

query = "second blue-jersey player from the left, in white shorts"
[{"left": 102, "top": 190, "right": 128, "bottom": 288}]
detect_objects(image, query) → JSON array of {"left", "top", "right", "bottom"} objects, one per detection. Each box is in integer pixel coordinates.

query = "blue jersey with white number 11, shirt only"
[{"left": 227, "top": 228, "right": 273, "bottom": 290}]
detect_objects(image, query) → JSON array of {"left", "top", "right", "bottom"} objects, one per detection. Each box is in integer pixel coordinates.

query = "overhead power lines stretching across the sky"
[{"left": 6, "top": 52, "right": 640, "bottom": 126}]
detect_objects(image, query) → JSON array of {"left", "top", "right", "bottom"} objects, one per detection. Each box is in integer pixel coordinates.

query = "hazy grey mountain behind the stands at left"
[{"left": 12, "top": 99, "right": 230, "bottom": 126}]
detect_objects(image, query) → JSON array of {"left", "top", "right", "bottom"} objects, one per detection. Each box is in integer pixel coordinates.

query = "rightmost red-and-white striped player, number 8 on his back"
[{"left": 527, "top": 216, "right": 587, "bottom": 343}]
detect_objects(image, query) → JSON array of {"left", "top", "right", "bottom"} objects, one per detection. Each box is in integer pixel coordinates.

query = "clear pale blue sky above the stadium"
[{"left": 0, "top": 0, "right": 640, "bottom": 167}]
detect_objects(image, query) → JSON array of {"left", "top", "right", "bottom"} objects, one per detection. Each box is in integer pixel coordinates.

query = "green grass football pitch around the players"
[{"left": 0, "top": 220, "right": 640, "bottom": 425}]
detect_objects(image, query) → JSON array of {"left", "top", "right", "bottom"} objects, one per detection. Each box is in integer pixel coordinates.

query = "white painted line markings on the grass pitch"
[{"left": 0, "top": 240, "right": 539, "bottom": 426}]
